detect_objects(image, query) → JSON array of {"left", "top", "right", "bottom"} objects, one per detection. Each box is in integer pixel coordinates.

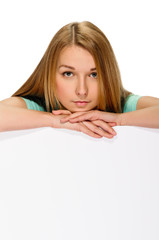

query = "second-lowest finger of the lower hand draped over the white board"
[{"left": 83, "top": 121, "right": 114, "bottom": 138}]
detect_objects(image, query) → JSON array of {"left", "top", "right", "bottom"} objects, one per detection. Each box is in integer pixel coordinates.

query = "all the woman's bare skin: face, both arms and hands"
[{"left": 0, "top": 46, "right": 159, "bottom": 138}]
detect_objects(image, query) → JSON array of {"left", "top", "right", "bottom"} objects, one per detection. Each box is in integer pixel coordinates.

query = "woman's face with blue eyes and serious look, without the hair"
[{"left": 56, "top": 46, "right": 98, "bottom": 112}]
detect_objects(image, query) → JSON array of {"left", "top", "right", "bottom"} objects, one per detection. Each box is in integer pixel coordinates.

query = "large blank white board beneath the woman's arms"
[{"left": 0, "top": 127, "right": 159, "bottom": 240}]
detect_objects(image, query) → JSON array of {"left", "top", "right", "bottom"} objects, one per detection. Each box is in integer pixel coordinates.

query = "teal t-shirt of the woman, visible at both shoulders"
[{"left": 22, "top": 94, "right": 141, "bottom": 113}]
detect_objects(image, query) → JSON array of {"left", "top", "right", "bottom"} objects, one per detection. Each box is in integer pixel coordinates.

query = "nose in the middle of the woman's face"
[{"left": 76, "top": 77, "right": 88, "bottom": 98}]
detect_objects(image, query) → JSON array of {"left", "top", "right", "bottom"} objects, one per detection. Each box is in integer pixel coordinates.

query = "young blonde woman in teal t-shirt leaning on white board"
[{"left": 0, "top": 21, "right": 159, "bottom": 138}]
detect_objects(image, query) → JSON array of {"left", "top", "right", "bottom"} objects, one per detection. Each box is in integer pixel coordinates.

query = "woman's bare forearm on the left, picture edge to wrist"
[{"left": 0, "top": 104, "right": 52, "bottom": 132}]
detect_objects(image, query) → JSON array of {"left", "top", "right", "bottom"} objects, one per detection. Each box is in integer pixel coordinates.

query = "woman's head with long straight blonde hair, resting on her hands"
[{"left": 13, "top": 21, "right": 129, "bottom": 112}]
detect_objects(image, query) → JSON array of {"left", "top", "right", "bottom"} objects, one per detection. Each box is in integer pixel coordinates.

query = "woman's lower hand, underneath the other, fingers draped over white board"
[{"left": 53, "top": 110, "right": 116, "bottom": 138}]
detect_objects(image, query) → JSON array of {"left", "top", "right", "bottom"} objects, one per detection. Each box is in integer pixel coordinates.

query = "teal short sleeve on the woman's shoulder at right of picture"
[{"left": 123, "top": 94, "right": 142, "bottom": 112}]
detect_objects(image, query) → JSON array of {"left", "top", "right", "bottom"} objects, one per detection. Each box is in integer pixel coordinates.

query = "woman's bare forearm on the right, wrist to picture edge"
[{"left": 120, "top": 106, "right": 159, "bottom": 128}]
